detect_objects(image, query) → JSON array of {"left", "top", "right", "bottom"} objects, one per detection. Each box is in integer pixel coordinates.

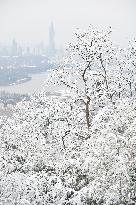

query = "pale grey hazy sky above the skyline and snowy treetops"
[{"left": 0, "top": 0, "right": 136, "bottom": 46}]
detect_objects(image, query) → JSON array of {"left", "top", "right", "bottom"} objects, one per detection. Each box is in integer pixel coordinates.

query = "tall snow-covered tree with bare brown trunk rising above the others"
[{"left": 46, "top": 26, "right": 118, "bottom": 129}]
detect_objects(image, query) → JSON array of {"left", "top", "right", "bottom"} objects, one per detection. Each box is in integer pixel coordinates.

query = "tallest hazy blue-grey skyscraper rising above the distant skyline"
[{"left": 48, "top": 22, "right": 56, "bottom": 57}]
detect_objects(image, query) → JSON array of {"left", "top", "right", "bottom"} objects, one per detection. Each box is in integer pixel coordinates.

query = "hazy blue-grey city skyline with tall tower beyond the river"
[{"left": 0, "top": 22, "right": 59, "bottom": 58}]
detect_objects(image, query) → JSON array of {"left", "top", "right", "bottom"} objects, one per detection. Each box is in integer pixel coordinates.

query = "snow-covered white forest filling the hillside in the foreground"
[{"left": 0, "top": 25, "right": 136, "bottom": 205}]
